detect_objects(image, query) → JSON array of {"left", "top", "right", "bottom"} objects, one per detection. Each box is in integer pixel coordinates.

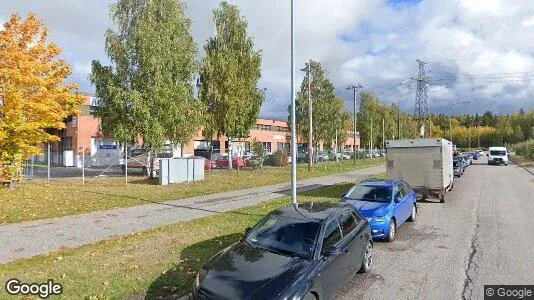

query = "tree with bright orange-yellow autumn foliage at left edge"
[{"left": 0, "top": 13, "right": 83, "bottom": 182}]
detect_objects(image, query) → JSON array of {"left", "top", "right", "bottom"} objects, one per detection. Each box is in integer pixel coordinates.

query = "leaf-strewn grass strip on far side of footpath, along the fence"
[{"left": 0, "top": 159, "right": 384, "bottom": 225}]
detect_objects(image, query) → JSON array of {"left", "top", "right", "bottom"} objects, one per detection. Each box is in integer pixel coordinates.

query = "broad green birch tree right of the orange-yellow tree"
[{"left": 91, "top": 0, "right": 202, "bottom": 176}]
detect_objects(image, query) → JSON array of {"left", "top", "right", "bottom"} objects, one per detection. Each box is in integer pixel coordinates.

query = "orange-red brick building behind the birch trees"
[{"left": 40, "top": 94, "right": 360, "bottom": 167}]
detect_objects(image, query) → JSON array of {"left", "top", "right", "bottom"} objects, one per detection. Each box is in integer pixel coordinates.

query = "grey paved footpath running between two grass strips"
[{"left": 0, "top": 166, "right": 385, "bottom": 264}]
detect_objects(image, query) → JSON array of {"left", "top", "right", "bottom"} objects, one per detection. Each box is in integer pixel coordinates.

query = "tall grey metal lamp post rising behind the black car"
[{"left": 291, "top": 0, "right": 298, "bottom": 209}]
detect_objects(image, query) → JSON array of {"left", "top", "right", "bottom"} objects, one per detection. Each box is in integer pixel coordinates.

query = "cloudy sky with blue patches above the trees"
[{"left": 0, "top": 0, "right": 534, "bottom": 120}]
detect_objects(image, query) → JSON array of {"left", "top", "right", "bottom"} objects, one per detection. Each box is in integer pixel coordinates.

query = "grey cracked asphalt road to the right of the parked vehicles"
[{"left": 336, "top": 158, "right": 534, "bottom": 299}]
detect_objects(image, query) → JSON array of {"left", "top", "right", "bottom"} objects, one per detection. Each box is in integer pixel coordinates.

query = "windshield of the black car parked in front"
[{"left": 245, "top": 214, "right": 320, "bottom": 259}]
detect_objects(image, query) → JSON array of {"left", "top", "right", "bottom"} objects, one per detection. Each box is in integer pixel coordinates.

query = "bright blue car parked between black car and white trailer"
[{"left": 341, "top": 180, "right": 417, "bottom": 242}]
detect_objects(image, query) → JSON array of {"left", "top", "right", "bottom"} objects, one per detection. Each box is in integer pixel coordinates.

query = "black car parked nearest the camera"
[{"left": 194, "top": 203, "right": 373, "bottom": 299}]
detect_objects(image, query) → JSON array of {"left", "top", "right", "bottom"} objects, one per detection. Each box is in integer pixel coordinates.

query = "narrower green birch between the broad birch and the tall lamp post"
[{"left": 200, "top": 2, "right": 265, "bottom": 169}]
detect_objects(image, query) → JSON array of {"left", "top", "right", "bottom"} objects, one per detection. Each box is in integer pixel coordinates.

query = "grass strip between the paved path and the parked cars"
[{"left": 0, "top": 174, "right": 385, "bottom": 299}]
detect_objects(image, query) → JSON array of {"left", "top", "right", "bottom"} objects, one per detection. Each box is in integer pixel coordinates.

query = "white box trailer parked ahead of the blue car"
[{"left": 386, "top": 138, "right": 454, "bottom": 203}]
